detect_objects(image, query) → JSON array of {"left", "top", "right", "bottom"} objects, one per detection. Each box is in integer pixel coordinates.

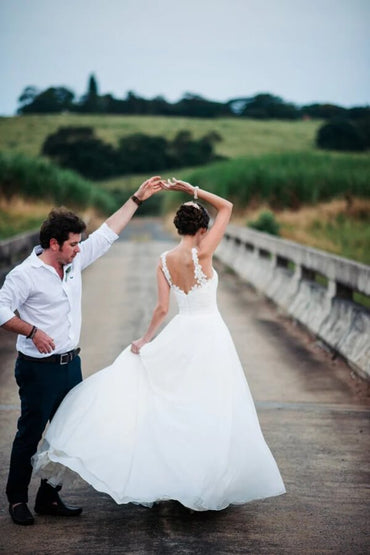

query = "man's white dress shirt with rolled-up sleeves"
[{"left": 0, "top": 223, "right": 118, "bottom": 358}]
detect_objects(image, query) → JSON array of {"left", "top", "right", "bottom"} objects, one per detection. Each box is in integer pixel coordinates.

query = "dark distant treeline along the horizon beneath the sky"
[{"left": 18, "top": 75, "right": 370, "bottom": 120}]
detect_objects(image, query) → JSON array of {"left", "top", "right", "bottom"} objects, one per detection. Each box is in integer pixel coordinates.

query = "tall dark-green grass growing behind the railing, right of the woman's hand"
[{"left": 164, "top": 152, "right": 370, "bottom": 210}]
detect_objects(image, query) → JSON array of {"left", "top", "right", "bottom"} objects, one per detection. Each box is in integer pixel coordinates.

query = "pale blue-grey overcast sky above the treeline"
[{"left": 0, "top": 0, "right": 370, "bottom": 115}]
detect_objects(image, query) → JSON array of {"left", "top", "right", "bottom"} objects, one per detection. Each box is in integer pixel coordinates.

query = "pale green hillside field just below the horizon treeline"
[{"left": 0, "top": 114, "right": 320, "bottom": 158}]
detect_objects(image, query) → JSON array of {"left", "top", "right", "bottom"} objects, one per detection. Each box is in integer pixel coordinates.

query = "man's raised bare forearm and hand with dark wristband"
[{"left": 105, "top": 175, "right": 162, "bottom": 235}]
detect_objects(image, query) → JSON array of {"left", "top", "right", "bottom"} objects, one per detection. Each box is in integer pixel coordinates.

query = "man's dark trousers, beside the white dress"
[{"left": 6, "top": 356, "right": 82, "bottom": 503}]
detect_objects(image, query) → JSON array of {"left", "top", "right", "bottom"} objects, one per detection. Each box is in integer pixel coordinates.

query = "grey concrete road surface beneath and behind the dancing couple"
[{"left": 0, "top": 219, "right": 370, "bottom": 555}]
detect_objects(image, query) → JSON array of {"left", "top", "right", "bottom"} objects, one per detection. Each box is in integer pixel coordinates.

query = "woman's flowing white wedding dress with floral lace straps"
[{"left": 33, "top": 249, "right": 285, "bottom": 511}]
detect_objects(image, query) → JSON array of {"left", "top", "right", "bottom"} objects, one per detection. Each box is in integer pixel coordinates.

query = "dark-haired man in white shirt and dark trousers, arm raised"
[{"left": 0, "top": 176, "right": 161, "bottom": 525}]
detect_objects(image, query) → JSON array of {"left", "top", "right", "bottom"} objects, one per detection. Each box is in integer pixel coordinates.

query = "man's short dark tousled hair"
[{"left": 40, "top": 206, "right": 86, "bottom": 249}]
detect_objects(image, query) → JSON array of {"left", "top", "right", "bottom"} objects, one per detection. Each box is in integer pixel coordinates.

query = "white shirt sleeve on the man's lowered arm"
[{"left": 0, "top": 268, "right": 29, "bottom": 326}]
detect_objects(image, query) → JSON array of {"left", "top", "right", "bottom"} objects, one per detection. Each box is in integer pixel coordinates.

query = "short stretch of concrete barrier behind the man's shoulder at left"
[{"left": 0, "top": 231, "right": 39, "bottom": 285}]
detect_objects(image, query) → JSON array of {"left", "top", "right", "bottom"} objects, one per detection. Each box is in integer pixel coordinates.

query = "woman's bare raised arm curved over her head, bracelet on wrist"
[{"left": 161, "top": 178, "right": 233, "bottom": 256}]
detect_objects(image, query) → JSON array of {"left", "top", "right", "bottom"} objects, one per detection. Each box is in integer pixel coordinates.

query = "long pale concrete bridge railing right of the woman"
[{"left": 216, "top": 225, "right": 370, "bottom": 378}]
